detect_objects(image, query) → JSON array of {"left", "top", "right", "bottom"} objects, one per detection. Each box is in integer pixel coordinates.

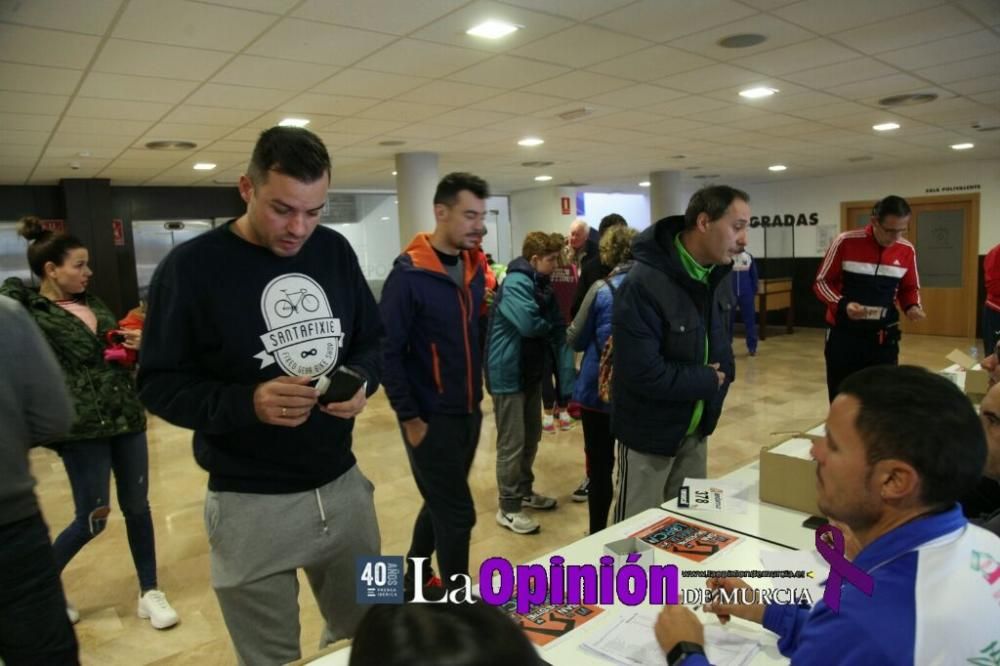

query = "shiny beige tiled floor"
[{"left": 32, "top": 329, "right": 973, "bottom": 666}]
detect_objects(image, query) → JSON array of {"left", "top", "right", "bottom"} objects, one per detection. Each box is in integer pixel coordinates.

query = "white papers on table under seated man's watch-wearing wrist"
[{"left": 583, "top": 609, "right": 760, "bottom": 666}]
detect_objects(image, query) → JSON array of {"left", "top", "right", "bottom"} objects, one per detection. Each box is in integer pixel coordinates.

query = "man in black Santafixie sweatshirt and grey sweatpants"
[{"left": 139, "top": 127, "right": 383, "bottom": 664}]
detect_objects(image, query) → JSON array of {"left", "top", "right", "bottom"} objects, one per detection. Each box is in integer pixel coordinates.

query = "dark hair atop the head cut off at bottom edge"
[{"left": 350, "top": 602, "right": 542, "bottom": 666}]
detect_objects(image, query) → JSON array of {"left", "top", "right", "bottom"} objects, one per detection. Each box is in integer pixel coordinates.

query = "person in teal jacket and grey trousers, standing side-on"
[{"left": 486, "top": 231, "right": 575, "bottom": 534}]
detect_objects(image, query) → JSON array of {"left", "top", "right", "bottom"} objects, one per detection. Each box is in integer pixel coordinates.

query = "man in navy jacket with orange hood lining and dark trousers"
[{"left": 379, "top": 173, "right": 489, "bottom": 599}]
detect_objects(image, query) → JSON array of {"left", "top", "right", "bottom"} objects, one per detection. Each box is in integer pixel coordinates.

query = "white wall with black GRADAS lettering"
[{"left": 732, "top": 160, "right": 1000, "bottom": 257}]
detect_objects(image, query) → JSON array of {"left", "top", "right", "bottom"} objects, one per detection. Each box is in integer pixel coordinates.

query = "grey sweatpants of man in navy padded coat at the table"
[{"left": 615, "top": 435, "right": 708, "bottom": 523}]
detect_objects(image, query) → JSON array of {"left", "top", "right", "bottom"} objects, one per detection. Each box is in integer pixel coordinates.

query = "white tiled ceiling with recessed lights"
[{"left": 0, "top": 0, "right": 1000, "bottom": 192}]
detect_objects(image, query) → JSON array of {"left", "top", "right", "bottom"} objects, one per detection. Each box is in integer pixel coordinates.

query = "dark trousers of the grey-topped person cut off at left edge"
[{"left": 0, "top": 513, "right": 80, "bottom": 666}]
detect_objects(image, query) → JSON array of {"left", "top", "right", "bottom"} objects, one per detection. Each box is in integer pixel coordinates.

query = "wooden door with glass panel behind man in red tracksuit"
[{"left": 841, "top": 194, "right": 979, "bottom": 338}]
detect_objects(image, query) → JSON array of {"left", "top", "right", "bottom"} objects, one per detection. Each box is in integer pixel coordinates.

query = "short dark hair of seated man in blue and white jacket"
[{"left": 840, "top": 365, "right": 986, "bottom": 508}]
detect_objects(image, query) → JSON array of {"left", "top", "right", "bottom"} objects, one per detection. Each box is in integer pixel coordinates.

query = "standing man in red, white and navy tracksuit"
[{"left": 813, "top": 196, "right": 926, "bottom": 402}]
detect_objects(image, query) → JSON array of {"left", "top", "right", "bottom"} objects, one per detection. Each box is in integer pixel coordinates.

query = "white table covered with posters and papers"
[{"left": 310, "top": 508, "right": 788, "bottom": 666}]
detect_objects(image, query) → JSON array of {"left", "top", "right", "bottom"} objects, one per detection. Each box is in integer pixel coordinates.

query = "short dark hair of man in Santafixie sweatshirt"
[{"left": 247, "top": 127, "right": 331, "bottom": 185}]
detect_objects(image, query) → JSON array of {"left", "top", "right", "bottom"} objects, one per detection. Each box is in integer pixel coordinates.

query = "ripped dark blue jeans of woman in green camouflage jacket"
[{"left": 53, "top": 432, "right": 156, "bottom": 592}]
